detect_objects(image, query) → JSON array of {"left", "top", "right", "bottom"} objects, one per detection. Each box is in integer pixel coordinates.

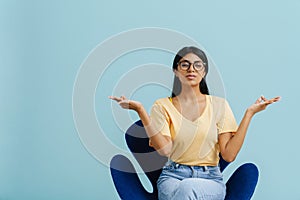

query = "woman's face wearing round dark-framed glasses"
[{"left": 174, "top": 53, "right": 205, "bottom": 86}]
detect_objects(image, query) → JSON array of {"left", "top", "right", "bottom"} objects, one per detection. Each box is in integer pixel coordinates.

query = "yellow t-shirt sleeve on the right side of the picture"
[{"left": 217, "top": 100, "right": 238, "bottom": 134}]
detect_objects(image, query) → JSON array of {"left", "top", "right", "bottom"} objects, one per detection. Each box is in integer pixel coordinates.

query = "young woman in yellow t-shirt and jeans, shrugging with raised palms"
[{"left": 109, "top": 47, "right": 280, "bottom": 200}]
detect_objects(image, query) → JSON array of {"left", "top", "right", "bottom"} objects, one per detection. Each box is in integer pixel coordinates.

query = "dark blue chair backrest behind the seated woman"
[{"left": 125, "top": 120, "right": 229, "bottom": 186}]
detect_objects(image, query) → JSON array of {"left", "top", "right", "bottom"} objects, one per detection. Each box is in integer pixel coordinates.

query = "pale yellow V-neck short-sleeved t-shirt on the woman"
[{"left": 150, "top": 95, "right": 238, "bottom": 166}]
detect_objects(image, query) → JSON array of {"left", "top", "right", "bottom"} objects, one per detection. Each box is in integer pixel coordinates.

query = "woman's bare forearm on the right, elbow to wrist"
[{"left": 222, "top": 110, "right": 254, "bottom": 161}]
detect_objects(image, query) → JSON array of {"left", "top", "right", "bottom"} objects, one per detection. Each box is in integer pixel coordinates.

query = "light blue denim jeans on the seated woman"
[{"left": 157, "top": 160, "right": 226, "bottom": 200}]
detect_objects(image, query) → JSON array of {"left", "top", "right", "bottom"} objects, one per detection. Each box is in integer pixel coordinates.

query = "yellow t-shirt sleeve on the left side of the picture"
[{"left": 149, "top": 102, "right": 171, "bottom": 146}]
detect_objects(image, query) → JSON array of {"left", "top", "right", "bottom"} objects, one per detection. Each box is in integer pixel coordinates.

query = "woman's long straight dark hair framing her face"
[{"left": 172, "top": 46, "right": 209, "bottom": 97}]
